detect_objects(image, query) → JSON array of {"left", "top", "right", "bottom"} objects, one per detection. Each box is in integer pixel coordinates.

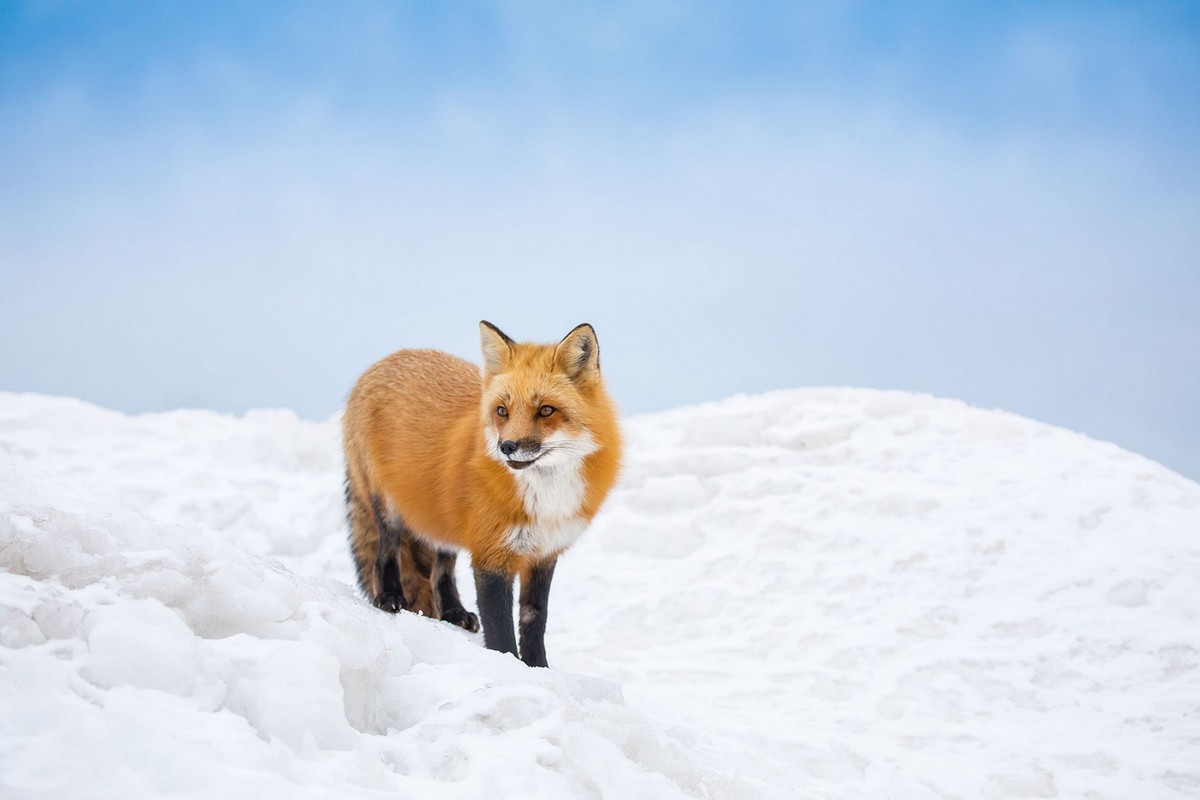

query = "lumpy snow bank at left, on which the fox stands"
[{"left": 0, "top": 395, "right": 746, "bottom": 798}]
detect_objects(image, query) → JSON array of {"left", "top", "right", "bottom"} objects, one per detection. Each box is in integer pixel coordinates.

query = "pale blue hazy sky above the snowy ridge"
[{"left": 0, "top": 1, "right": 1200, "bottom": 477}]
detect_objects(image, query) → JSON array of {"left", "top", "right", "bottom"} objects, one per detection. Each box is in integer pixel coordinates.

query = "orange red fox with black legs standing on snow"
[{"left": 342, "top": 320, "right": 622, "bottom": 667}]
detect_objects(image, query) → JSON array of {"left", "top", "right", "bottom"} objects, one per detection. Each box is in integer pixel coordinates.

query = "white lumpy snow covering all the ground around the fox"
[{"left": 0, "top": 390, "right": 1200, "bottom": 800}]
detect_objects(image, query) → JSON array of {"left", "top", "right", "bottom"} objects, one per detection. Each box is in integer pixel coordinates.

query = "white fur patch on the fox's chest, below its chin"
[{"left": 508, "top": 459, "right": 588, "bottom": 555}]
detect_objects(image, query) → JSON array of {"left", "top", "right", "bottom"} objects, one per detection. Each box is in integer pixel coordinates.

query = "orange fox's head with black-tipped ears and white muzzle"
[{"left": 479, "top": 321, "right": 612, "bottom": 470}]
